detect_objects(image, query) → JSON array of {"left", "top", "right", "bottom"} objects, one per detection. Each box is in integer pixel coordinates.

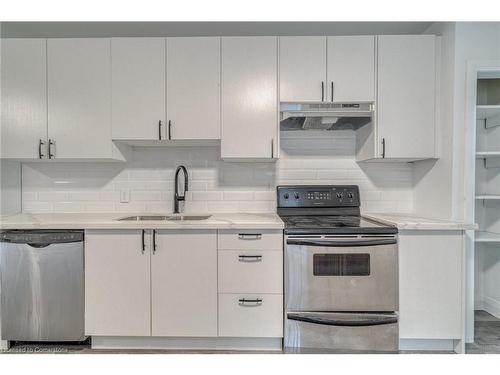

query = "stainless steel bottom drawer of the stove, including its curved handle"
[{"left": 284, "top": 312, "right": 399, "bottom": 353}]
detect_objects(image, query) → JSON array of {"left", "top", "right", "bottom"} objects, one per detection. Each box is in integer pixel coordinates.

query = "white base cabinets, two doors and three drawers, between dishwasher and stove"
[{"left": 85, "top": 229, "right": 283, "bottom": 338}]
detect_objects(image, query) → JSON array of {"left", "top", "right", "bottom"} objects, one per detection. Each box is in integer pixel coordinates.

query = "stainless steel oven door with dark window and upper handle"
[{"left": 285, "top": 236, "right": 398, "bottom": 311}]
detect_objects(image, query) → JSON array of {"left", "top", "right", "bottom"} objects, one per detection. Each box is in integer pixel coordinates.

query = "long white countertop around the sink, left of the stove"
[{"left": 0, "top": 212, "right": 283, "bottom": 229}]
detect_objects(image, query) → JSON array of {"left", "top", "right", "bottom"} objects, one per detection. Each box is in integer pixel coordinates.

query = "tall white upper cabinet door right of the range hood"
[{"left": 376, "top": 35, "right": 436, "bottom": 159}]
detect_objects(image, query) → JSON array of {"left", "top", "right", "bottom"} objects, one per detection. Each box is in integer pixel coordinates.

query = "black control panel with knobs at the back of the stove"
[{"left": 277, "top": 185, "right": 360, "bottom": 207}]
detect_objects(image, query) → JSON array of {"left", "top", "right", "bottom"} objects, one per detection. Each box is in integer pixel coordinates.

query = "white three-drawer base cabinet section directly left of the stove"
[{"left": 218, "top": 230, "right": 283, "bottom": 337}]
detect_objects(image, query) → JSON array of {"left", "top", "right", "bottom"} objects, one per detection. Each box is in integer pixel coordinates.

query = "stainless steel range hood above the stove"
[{"left": 280, "top": 102, "right": 374, "bottom": 130}]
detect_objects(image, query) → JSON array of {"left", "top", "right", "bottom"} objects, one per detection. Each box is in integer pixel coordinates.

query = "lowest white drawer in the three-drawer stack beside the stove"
[{"left": 219, "top": 294, "right": 283, "bottom": 337}]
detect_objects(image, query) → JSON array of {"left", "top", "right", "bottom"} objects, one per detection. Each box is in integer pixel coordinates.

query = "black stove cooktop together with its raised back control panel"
[{"left": 277, "top": 185, "right": 398, "bottom": 234}]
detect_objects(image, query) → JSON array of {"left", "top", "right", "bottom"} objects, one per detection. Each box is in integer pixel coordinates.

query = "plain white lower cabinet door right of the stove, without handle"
[{"left": 399, "top": 231, "right": 464, "bottom": 339}]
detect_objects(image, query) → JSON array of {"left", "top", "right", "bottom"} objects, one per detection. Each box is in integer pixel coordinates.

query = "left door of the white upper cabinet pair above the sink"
[{"left": 111, "top": 38, "right": 166, "bottom": 140}]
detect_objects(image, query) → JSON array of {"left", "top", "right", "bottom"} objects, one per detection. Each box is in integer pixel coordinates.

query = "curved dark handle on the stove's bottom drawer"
[{"left": 287, "top": 313, "right": 398, "bottom": 327}]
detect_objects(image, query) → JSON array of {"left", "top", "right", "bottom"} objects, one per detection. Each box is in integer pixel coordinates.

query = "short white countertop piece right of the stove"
[{"left": 363, "top": 212, "right": 477, "bottom": 230}]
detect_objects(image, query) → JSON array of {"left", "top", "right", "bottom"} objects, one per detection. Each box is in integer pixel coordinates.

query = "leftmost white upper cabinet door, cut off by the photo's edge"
[{"left": 0, "top": 39, "right": 47, "bottom": 159}]
